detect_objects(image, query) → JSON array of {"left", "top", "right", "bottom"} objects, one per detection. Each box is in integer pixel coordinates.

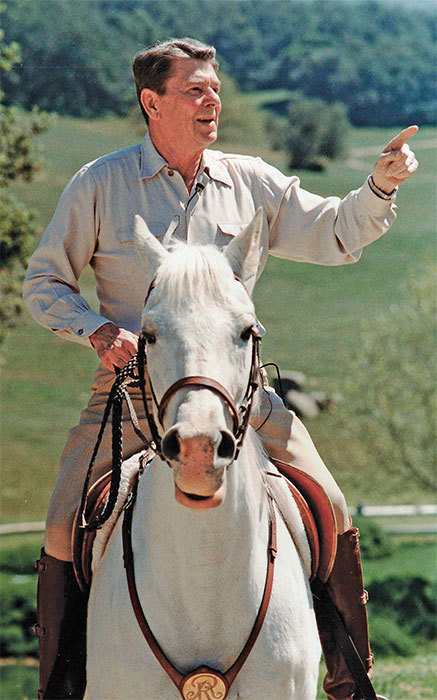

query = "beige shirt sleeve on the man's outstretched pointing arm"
[{"left": 259, "top": 161, "right": 396, "bottom": 265}]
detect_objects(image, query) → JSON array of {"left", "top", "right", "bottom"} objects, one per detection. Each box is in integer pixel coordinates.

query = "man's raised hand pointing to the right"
[{"left": 372, "top": 126, "right": 419, "bottom": 194}]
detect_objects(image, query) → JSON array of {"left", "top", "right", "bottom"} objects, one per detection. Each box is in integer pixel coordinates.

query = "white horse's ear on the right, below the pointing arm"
[{"left": 223, "top": 207, "right": 265, "bottom": 294}]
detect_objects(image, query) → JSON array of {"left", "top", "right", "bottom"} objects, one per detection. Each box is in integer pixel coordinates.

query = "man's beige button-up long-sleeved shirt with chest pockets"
[{"left": 23, "top": 134, "right": 395, "bottom": 344}]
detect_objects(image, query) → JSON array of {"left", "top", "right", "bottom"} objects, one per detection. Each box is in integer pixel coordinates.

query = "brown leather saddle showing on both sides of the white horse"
[{"left": 72, "top": 460, "right": 337, "bottom": 593}]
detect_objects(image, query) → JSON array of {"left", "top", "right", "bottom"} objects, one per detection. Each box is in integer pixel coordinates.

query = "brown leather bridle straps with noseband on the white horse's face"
[{"left": 138, "top": 275, "right": 261, "bottom": 460}]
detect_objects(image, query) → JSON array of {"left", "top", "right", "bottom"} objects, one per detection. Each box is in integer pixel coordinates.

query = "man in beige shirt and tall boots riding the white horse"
[{"left": 24, "top": 39, "right": 417, "bottom": 699}]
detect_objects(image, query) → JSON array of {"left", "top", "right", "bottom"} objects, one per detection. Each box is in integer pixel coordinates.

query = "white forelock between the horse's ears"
[{"left": 155, "top": 242, "right": 234, "bottom": 308}]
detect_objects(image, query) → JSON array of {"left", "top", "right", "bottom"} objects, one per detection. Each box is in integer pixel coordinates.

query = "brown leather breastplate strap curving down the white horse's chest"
[{"left": 123, "top": 479, "right": 277, "bottom": 697}]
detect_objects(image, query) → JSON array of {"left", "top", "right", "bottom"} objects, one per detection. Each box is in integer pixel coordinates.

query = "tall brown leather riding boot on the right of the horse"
[{"left": 313, "top": 527, "right": 377, "bottom": 700}]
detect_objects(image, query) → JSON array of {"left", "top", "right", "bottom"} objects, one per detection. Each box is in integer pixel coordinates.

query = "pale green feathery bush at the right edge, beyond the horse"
[{"left": 337, "top": 270, "right": 437, "bottom": 490}]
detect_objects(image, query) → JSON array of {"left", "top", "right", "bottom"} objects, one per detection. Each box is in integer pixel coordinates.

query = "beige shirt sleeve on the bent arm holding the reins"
[{"left": 23, "top": 166, "right": 108, "bottom": 345}]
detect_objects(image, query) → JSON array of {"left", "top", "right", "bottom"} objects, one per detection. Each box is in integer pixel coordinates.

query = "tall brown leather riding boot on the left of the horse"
[{"left": 35, "top": 549, "right": 87, "bottom": 700}]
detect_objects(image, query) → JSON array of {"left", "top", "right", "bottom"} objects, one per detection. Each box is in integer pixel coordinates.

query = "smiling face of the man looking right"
[{"left": 146, "top": 58, "right": 221, "bottom": 156}]
